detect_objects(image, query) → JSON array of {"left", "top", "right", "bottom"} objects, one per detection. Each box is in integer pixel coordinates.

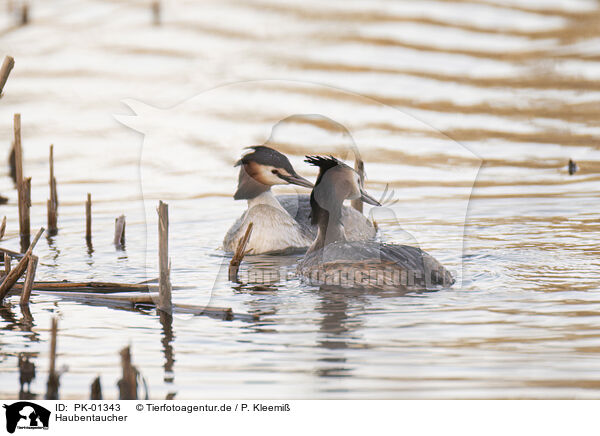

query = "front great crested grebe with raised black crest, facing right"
[{"left": 297, "top": 156, "right": 454, "bottom": 290}]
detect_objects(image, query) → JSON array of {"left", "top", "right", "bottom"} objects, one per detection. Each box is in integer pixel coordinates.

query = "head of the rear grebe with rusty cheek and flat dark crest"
[{"left": 233, "top": 145, "right": 313, "bottom": 200}]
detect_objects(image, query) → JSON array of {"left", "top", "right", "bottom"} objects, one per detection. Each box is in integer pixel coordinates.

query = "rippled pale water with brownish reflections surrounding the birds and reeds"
[{"left": 0, "top": 0, "right": 600, "bottom": 399}]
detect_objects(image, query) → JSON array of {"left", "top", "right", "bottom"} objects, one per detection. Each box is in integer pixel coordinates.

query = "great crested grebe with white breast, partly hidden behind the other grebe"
[{"left": 223, "top": 145, "right": 376, "bottom": 254}]
